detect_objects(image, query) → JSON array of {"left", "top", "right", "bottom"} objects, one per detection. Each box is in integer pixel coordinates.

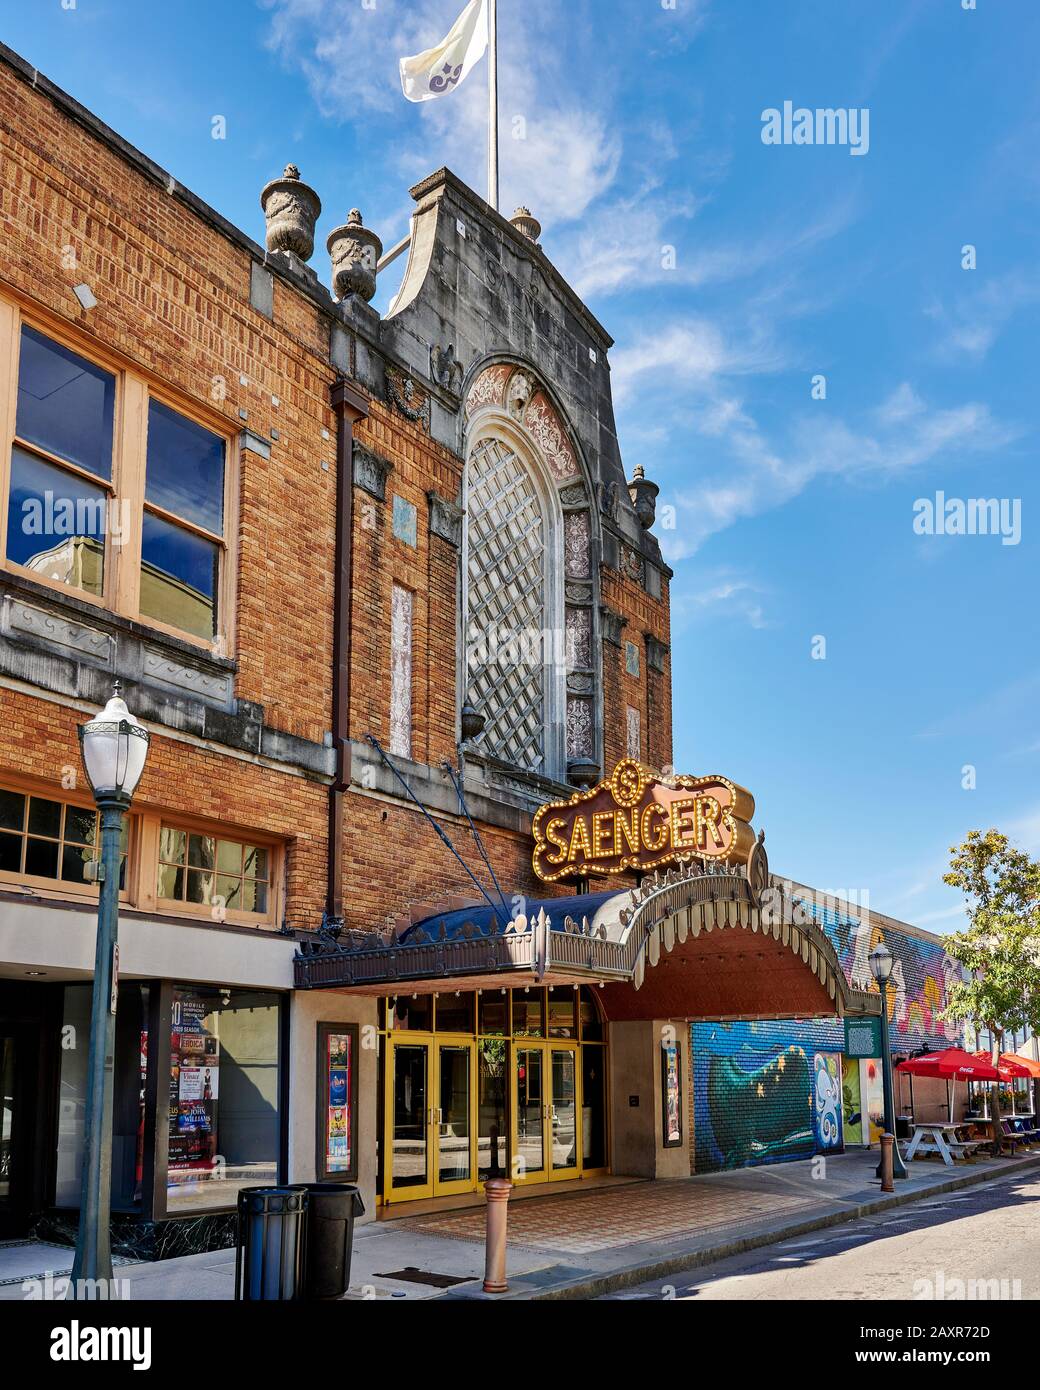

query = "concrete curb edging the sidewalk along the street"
[{"left": 475, "top": 1154, "right": 1040, "bottom": 1302}]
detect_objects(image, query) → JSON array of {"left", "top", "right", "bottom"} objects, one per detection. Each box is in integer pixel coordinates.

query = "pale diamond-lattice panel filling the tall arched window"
[{"left": 464, "top": 435, "right": 566, "bottom": 777}]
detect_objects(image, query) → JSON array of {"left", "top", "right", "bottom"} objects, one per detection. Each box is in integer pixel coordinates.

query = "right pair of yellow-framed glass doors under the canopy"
[{"left": 513, "top": 1041, "right": 581, "bottom": 1183}]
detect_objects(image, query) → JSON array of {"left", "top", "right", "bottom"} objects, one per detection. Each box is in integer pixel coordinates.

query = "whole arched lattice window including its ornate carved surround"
[{"left": 460, "top": 363, "right": 601, "bottom": 785}]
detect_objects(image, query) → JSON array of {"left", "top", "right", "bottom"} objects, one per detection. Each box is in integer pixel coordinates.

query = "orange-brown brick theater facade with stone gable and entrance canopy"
[{"left": 0, "top": 38, "right": 956, "bottom": 1255}]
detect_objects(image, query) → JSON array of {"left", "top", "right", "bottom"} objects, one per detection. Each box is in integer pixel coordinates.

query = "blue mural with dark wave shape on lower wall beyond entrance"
[{"left": 691, "top": 1019, "right": 844, "bottom": 1172}]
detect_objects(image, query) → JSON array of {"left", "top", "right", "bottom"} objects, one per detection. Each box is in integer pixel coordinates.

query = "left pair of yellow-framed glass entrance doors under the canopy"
[{"left": 382, "top": 1036, "right": 477, "bottom": 1202}]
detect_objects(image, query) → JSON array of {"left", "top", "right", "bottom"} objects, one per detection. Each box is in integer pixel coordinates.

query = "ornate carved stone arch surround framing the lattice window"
[{"left": 459, "top": 360, "right": 602, "bottom": 785}]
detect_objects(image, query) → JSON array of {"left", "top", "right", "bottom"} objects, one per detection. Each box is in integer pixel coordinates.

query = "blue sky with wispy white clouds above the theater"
[{"left": 0, "top": 0, "right": 1040, "bottom": 931}]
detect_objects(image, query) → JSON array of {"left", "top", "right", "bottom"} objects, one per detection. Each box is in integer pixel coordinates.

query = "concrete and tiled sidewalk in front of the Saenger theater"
[{"left": 0, "top": 1150, "right": 1040, "bottom": 1301}]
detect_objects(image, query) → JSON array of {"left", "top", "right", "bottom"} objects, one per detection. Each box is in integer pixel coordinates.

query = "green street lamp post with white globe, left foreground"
[{"left": 68, "top": 681, "right": 149, "bottom": 1298}]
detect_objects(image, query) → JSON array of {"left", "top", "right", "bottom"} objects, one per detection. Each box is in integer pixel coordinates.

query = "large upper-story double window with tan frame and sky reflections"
[{"left": 0, "top": 302, "right": 232, "bottom": 651}]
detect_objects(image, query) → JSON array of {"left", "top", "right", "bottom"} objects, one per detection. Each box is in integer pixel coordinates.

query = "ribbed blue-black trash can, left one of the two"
[{"left": 235, "top": 1186, "right": 309, "bottom": 1302}]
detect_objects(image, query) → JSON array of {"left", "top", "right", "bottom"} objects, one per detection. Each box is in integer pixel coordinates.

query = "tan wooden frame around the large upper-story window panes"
[{"left": 0, "top": 295, "right": 241, "bottom": 656}]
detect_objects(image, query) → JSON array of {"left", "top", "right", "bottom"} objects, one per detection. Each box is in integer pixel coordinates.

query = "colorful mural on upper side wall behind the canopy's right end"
[{"left": 805, "top": 901, "right": 961, "bottom": 1054}]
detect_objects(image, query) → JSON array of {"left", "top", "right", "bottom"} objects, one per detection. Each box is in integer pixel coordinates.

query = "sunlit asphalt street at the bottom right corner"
[{"left": 609, "top": 1173, "right": 1040, "bottom": 1301}]
